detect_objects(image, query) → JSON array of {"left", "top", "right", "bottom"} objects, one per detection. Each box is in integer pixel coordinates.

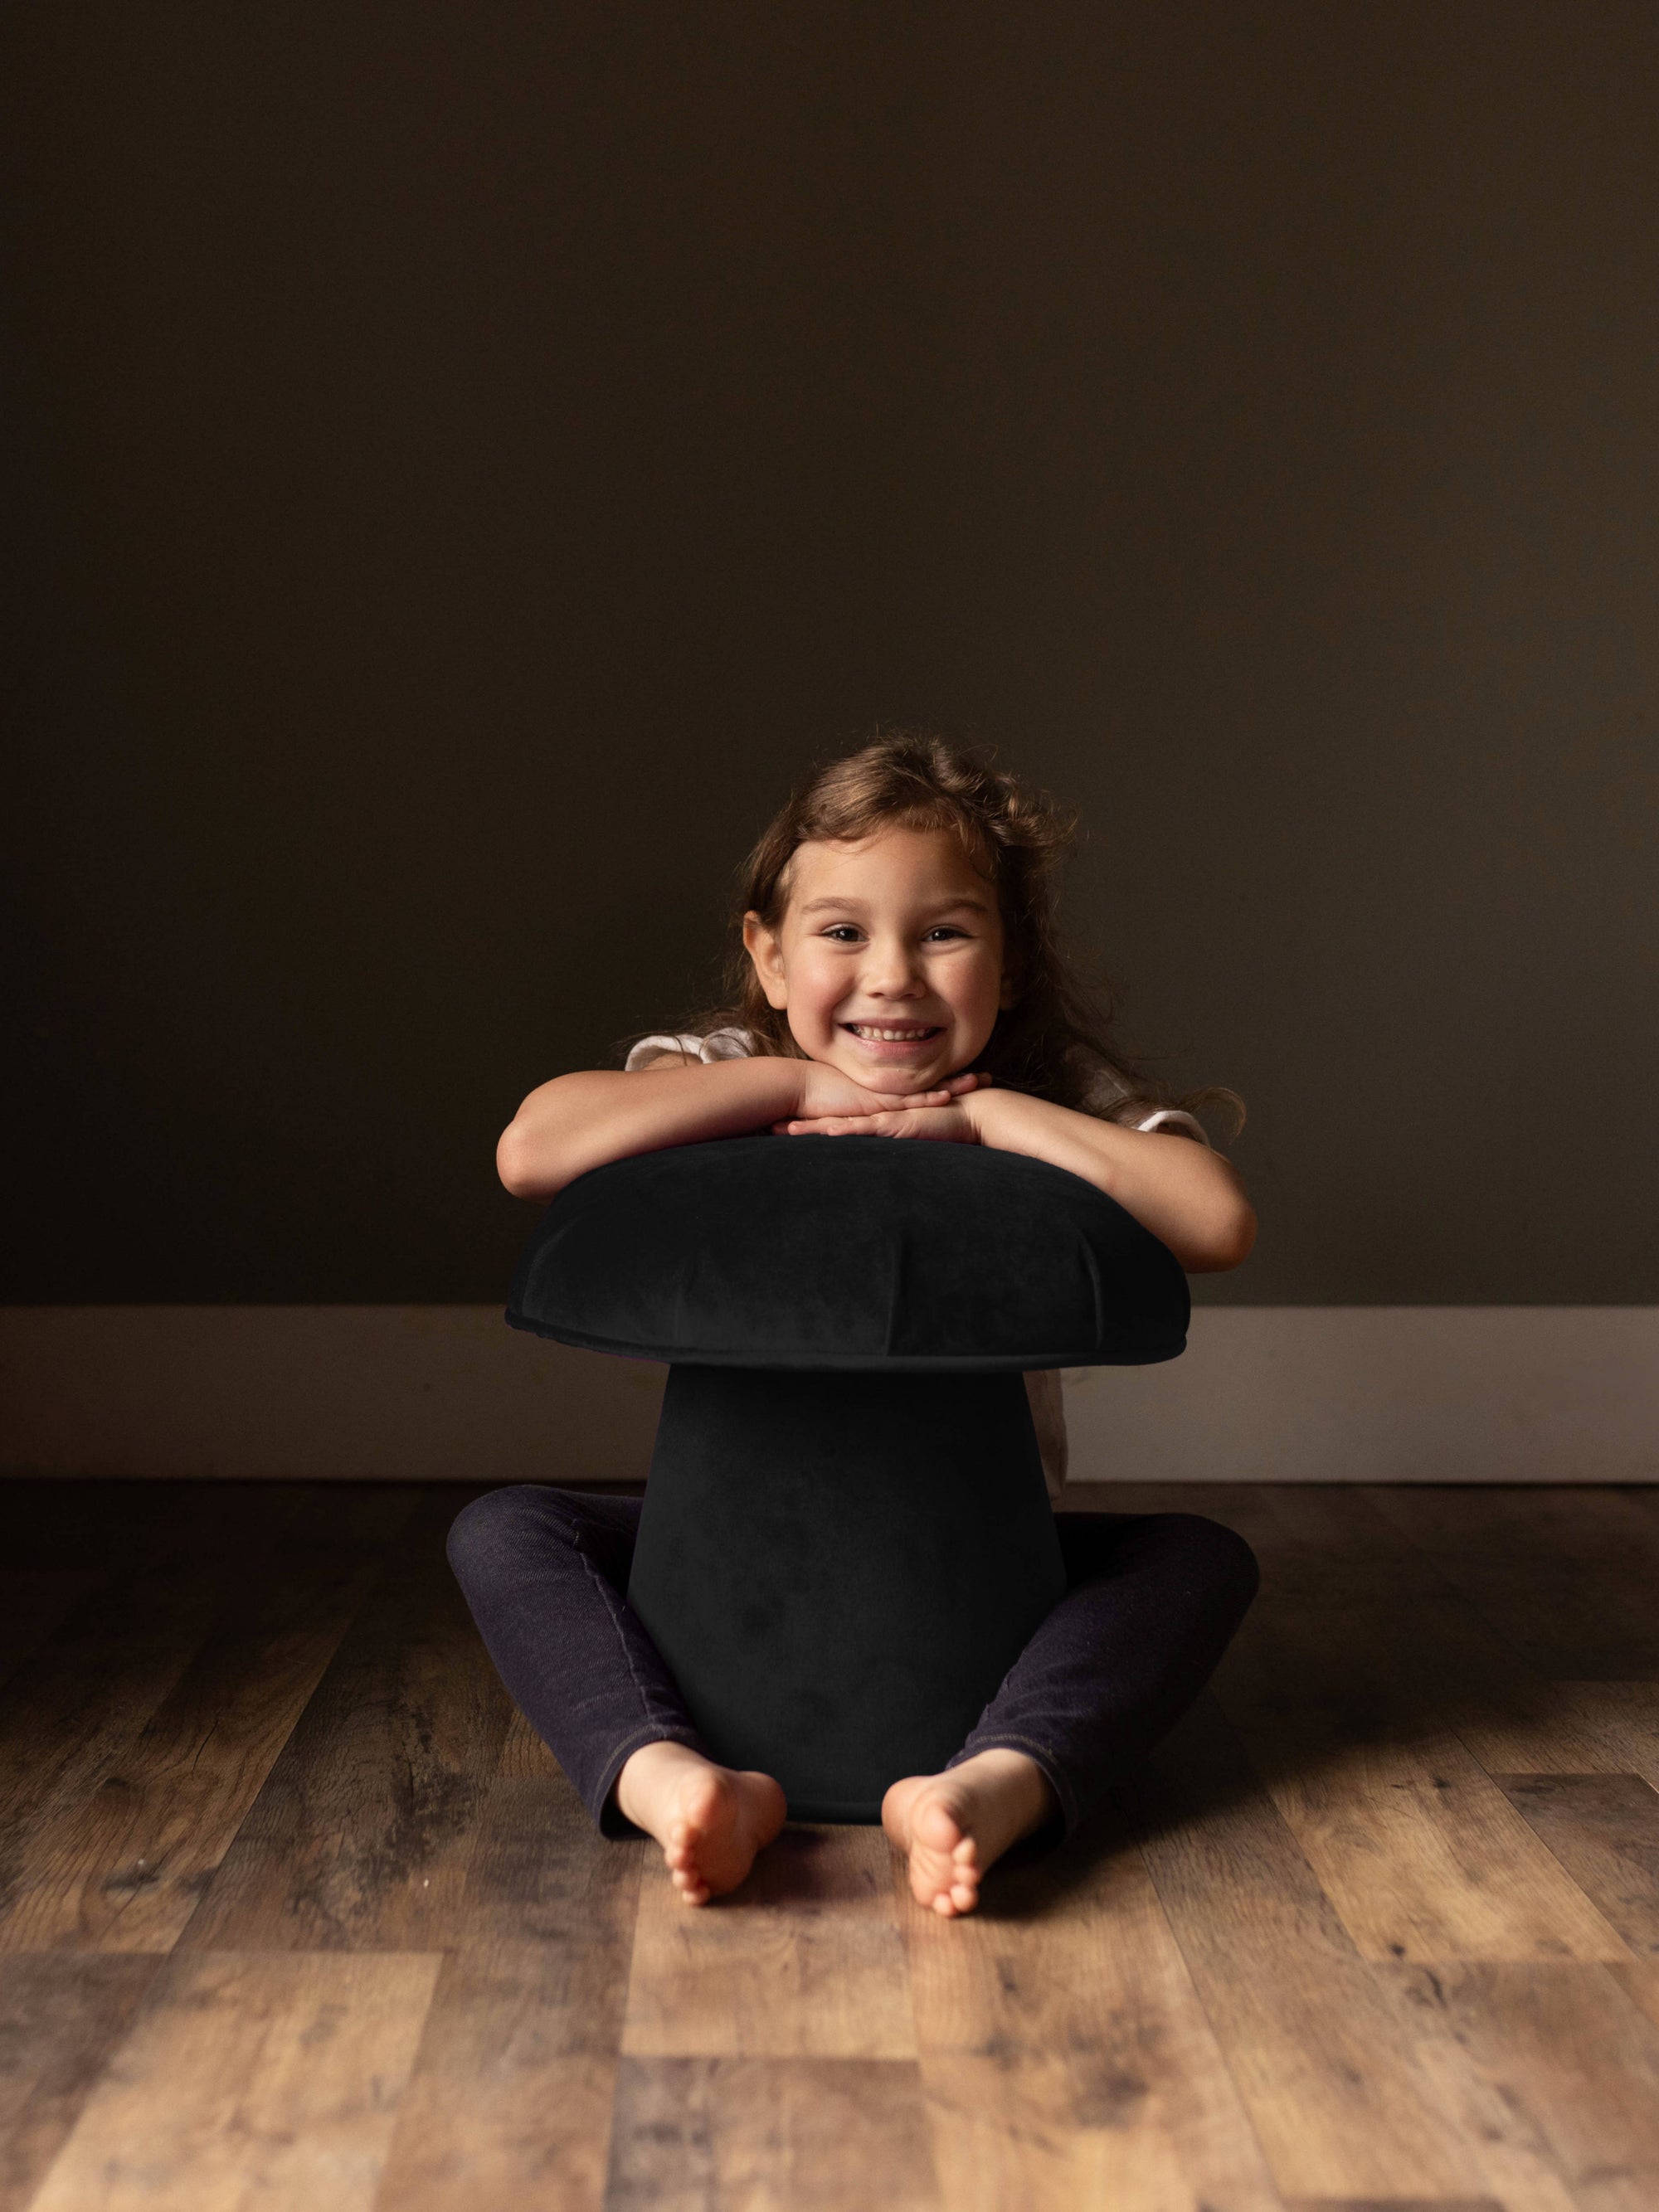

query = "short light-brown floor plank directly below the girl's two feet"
[{"left": 621, "top": 1827, "right": 916, "bottom": 2059}]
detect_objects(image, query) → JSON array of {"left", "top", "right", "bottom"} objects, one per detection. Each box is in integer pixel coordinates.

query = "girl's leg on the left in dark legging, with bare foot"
[{"left": 449, "top": 1482, "right": 783, "bottom": 1904}]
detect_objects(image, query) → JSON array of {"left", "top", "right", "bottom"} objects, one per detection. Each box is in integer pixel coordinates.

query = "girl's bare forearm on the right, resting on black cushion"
[{"left": 962, "top": 1091, "right": 1257, "bottom": 1274}]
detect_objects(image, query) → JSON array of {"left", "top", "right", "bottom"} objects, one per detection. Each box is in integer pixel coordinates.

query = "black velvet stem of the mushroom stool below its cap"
[{"left": 628, "top": 1365, "right": 1066, "bottom": 1821}]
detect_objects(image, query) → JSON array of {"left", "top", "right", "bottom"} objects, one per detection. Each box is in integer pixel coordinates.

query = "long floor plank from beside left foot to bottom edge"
[{"left": 378, "top": 1738, "right": 641, "bottom": 2212}]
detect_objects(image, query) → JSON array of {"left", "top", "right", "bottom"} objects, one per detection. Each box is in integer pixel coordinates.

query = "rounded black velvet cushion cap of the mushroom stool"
[{"left": 507, "top": 1137, "right": 1188, "bottom": 1373}]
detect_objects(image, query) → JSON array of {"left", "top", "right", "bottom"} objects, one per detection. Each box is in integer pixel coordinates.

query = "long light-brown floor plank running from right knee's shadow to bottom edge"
[{"left": 1119, "top": 1697, "right": 1569, "bottom": 2212}]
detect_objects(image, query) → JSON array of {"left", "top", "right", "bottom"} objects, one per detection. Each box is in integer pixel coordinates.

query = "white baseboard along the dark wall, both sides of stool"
[{"left": 0, "top": 1305, "right": 1659, "bottom": 1482}]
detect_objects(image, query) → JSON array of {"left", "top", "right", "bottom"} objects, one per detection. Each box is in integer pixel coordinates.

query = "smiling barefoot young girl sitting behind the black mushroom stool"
[{"left": 449, "top": 734, "right": 1257, "bottom": 1916}]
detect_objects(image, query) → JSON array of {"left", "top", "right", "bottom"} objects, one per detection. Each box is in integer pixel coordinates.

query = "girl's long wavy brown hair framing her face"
[{"left": 641, "top": 730, "right": 1243, "bottom": 1133}]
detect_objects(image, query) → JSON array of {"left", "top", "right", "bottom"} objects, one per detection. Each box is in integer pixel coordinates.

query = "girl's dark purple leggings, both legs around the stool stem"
[{"left": 449, "top": 1482, "right": 1258, "bottom": 1836}]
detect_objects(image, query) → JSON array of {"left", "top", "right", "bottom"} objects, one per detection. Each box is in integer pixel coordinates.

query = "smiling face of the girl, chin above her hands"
[{"left": 743, "top": 827, "right": 1013, "bottom": 1092}]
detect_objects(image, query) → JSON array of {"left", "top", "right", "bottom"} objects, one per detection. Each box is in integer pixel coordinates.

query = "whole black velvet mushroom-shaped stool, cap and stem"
[{"left": 507, "top": 1137, "right": 1188, "bottom": 1821}]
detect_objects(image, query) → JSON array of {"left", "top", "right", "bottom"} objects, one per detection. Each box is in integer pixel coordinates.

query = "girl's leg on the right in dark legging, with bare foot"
[{"left": 883, "top": 1513, "right": 1258, "bottom": 1913}]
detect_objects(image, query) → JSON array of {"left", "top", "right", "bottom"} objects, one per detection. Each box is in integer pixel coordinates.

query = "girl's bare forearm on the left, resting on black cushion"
[{"left": 495, "top": 1059, "right": 800, "bottom": 1199}]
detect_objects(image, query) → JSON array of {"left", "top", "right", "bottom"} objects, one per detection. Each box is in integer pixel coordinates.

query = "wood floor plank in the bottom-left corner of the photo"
[{"left": 0, "top": 1953, "right": 157, "bottom": 2212}]
